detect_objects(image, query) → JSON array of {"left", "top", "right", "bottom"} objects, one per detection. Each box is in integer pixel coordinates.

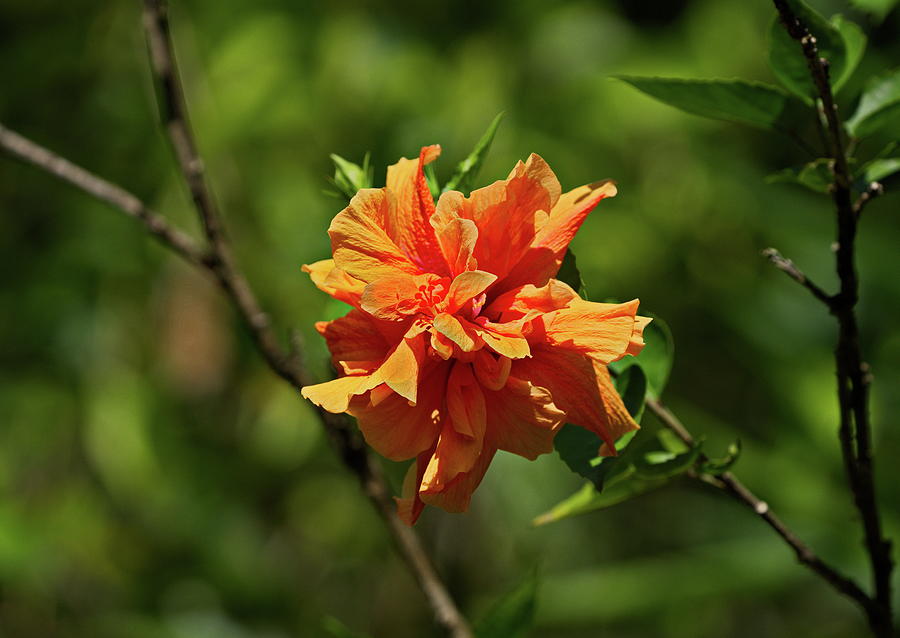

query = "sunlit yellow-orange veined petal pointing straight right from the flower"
[{"left": 543, "top": 299, "right": 642, "bottom": 364}]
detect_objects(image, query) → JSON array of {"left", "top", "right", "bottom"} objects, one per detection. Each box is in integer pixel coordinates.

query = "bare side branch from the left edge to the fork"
[{"left": 0, "top": 124, "right": 208, "bottom": 264}]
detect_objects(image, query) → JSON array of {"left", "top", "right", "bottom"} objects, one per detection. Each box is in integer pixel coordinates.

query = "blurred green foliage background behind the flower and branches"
[{"left": 0, "top": 0, "right": 900, "bottom": 638}]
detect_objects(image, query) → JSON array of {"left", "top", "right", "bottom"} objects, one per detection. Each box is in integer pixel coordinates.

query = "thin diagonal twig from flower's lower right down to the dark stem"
[{"left": 647, "top": 399, "right": 875, "bottom": 620}]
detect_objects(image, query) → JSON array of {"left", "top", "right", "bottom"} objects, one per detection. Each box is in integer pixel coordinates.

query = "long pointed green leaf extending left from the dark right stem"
[{"left": 614, "top": 75, "right": 799, "bottom": 130}]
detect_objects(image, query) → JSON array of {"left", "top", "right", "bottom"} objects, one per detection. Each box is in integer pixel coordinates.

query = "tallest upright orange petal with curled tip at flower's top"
[{"left": 385, "top": 144, "right": 447, "bottom": 275}]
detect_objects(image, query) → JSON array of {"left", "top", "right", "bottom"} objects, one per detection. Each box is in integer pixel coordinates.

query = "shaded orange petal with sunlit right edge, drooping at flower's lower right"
[{"left": 510, "top": 345, "right": 639, "bottom": 449}]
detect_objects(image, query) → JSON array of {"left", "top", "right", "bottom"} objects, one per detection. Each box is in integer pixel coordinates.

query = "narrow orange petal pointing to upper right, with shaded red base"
[{"left": 502, "top": 180, "right": 616, "bottom": 289}]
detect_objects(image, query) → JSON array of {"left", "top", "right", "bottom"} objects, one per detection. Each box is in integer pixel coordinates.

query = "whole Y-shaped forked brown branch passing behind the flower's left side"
[{"left": 0, "top": 6, "right": 472, "bottom": 638}]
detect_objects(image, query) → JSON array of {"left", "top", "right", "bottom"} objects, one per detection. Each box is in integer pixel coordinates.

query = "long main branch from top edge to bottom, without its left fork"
[{"left": 138, "top": 0, "right": 471, "bottom": 638}]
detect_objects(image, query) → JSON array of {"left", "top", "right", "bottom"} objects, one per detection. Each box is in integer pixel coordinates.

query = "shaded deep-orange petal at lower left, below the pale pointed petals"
[{"left": 349, "top": 364, "right": 449, "bottom": 461}]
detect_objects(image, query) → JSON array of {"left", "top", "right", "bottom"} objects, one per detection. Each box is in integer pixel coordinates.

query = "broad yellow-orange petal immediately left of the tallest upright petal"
[{"left": 328, "top": 188, "right": 420, "bottom": 283}]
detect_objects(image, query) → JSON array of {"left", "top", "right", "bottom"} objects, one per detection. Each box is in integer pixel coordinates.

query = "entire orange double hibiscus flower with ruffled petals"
[{"left": 303, "top": 146, "right": 650, "bottom": 524}]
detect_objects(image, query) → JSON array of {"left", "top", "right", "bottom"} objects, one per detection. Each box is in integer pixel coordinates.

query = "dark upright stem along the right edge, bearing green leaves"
[{"left": 774, "top": 0, "right": 893, "bottom": 636}]
